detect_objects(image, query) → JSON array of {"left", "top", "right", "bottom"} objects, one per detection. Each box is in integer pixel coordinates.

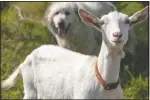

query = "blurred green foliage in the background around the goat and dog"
[{"left": 1, "top": 2, "right": 148, "bottom": 99}]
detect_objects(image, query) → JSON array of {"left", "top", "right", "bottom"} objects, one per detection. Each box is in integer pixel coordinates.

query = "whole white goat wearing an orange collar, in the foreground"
[{"left": 2, "top": 7, "right": 148, "bottom": 99}]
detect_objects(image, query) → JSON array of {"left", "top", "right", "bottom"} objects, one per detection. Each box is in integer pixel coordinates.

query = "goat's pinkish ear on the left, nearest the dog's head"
[{"left": 78, "top": 9, "right": 99, "bottom": 27}]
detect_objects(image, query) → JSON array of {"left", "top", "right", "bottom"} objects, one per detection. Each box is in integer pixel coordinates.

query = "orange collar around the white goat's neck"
[{"left": 95, "top": 63, "right": 119, "bottom": 90}]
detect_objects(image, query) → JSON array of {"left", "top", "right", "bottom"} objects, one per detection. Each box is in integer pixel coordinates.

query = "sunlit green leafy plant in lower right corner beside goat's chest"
[{"left": 123, "top": 66, "right": 148, "bottom": 99}]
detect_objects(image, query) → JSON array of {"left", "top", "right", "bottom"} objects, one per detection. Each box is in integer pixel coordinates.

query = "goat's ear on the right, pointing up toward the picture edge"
[{"left": 129, "top": 6, "right": 149, "bottom": 26}]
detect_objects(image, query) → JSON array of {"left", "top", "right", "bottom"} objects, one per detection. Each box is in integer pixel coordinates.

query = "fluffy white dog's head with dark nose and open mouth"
[{"left": 45, "top": 2, "right": 77, "bottom": 36}]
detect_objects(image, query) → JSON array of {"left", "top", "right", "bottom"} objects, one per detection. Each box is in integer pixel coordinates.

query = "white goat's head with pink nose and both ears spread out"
[{"left": 78, "top": 7, "right": 149, "bottom": 48}]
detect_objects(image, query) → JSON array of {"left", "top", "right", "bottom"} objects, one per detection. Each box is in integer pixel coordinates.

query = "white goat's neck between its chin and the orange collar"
[{"left": 98, "top": 41, "right": 121, "bottom": 83}]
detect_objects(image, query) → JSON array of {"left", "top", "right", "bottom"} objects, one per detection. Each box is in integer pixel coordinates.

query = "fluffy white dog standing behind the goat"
[{"left": 45, "top": 2, "right": 135, "bottom": 55}]
